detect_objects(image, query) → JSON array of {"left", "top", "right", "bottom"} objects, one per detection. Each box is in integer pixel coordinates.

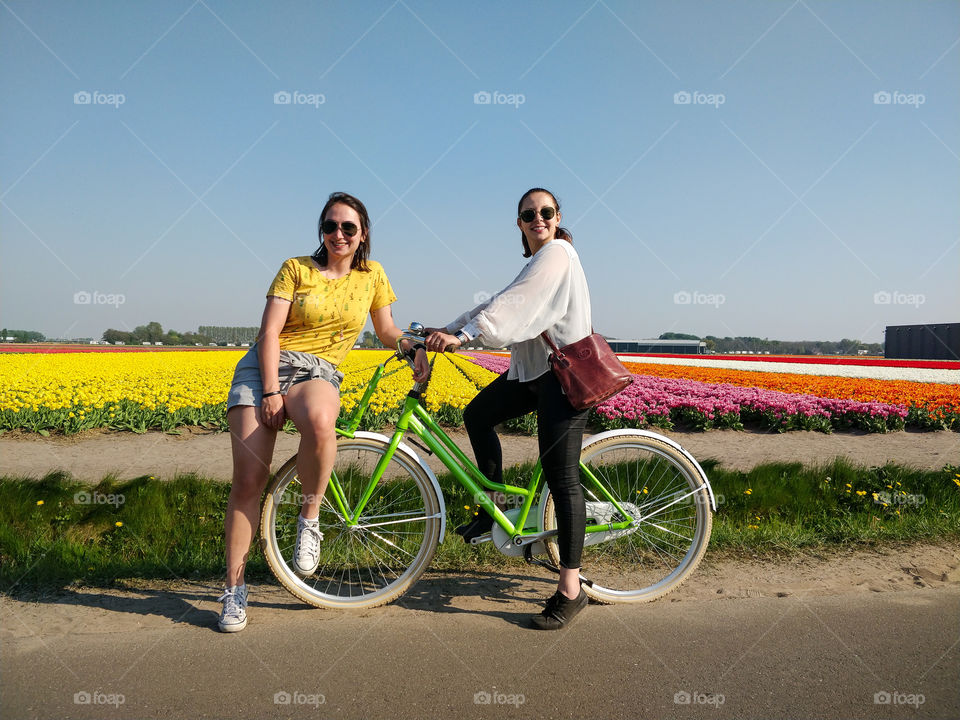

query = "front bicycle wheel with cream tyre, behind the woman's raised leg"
[{"left": 260, "top": 438, "right": 441, "bottom": 608}]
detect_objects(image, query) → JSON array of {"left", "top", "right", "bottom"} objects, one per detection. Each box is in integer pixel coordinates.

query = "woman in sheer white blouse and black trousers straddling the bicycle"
[{"left": 426, "top": 188, "right": 592, "bottom": 630}]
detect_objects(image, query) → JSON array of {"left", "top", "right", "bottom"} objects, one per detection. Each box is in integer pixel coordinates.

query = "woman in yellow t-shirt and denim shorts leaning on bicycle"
[{"left": 219, "top": 193, "right": 430, "bottom": 632}]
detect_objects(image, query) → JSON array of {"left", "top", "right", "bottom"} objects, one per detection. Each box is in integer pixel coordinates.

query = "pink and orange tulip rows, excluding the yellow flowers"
[{"left": 462, "top": 354, "right": 960, "bottom": 432}]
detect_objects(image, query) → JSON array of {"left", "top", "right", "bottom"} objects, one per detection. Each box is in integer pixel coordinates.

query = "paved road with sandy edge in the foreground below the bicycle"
[{"left": 0, "top": 573, "right": 960, "bottom": 720}]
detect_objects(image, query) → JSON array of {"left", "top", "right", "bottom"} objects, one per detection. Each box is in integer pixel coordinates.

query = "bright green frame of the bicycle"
[{"left": 328, "top": 355, "right": 637, "bottom": 544}]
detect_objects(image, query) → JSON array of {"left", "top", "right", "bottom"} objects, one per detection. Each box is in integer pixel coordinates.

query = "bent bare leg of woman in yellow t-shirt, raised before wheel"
[{"left": 285, "top": 380, "right": 340, "bottom": 520}]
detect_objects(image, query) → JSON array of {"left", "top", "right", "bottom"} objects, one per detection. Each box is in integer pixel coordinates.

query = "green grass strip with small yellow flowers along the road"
[{"left": 0, "top": 460, "right": 960, "bottom": 592}]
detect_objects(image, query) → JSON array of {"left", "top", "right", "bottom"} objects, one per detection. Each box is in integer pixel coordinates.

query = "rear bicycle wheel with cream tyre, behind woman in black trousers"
[{"left": 543, "top": 434, "right": 712, "bottom": 603}]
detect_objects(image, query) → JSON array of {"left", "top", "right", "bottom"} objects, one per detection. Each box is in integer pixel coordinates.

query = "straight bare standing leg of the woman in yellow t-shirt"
[{"left": 224, "top": 405, "right": 277, "bottom": 587}]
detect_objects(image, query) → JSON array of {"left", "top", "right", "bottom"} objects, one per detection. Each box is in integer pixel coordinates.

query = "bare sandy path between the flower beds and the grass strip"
[{"left": 0, "top": 429, "right": 960, "bottom": 481}]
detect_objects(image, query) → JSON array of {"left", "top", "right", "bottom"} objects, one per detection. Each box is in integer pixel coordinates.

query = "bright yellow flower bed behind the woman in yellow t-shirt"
[{"left": 0, "top": 350, "right": 496, "bottom": 434}]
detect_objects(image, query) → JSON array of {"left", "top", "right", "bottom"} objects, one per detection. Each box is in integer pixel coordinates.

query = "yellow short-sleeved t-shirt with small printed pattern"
[{"left": 267, "top": 256, "right": 397, "bottom": 367}]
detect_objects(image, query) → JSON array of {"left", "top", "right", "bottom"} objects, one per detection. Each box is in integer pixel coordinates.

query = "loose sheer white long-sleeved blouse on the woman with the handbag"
[{"left": 446, "top": 239, "right": 593, "bottom": 382}]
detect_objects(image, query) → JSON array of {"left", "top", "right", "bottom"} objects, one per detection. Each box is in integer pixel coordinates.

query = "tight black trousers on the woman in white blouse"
[{"left": 463, "top": 371, "right": 589, "bottom": 568}]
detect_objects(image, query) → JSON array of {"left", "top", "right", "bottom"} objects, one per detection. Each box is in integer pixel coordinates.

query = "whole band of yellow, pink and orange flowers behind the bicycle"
[{"left": 0, "top": 350, "right": 960, "bottom": 433}]
